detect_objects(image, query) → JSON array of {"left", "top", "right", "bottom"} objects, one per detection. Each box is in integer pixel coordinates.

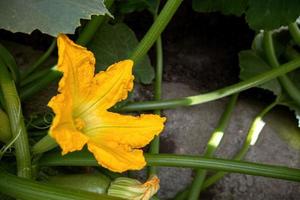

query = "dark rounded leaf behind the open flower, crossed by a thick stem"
[{"left": 88, "top": 23, "right": 154, "bottom": 84}]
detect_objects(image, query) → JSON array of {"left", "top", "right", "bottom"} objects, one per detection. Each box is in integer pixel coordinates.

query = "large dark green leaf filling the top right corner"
[{"left": 246, "top": 0, "right": 300, "bottom": 30}]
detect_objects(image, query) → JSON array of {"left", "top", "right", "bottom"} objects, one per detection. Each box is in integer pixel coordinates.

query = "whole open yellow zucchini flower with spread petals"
[{"left": 48, "top": 34, "right": 166, "bottom": 172}]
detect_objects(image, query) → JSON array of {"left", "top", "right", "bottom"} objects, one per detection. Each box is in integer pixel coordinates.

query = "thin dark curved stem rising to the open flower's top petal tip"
[{"left": 21, "top": 38, "right": 56, "bottom": 80}]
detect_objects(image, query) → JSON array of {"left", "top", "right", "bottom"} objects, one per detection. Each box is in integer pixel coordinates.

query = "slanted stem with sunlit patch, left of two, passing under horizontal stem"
[{"left": 187, "top": 94, "right": 238, "bottom": 200}]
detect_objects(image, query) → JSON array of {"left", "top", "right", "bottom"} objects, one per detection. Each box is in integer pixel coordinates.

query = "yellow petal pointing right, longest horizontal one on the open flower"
[{"left": 83, "top": 112, "right": 166, "bottom": 148}]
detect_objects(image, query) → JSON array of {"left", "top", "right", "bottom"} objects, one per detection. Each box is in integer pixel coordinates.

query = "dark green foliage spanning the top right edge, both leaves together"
[{"left": 193, "top": 0, "right": 300, "bottom": 30}]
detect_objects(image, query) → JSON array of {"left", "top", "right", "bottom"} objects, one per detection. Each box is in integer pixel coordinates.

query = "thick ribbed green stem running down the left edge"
[{"left": 0, "top": 60, "right": 31, "bottom": 178}]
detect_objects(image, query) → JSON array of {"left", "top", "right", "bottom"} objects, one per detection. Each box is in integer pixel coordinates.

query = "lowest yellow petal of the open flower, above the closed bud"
[{"left": 88, "top": 141, "right": 146, "bottom": 173}]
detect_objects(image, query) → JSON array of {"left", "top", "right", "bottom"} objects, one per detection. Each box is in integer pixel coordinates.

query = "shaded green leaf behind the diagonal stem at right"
[{"left": 239, "top": 50, "right": 281, "bottom": 95}]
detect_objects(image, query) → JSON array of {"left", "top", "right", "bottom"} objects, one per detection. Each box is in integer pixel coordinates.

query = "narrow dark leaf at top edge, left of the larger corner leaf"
[{"left": 193, "top": 0, "right": 248, "bottom": 16}]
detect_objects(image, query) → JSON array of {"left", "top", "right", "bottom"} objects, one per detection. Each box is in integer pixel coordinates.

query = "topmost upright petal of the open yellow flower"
[{"left": 57, "top": 34, "right": 95, "bottom": 107}]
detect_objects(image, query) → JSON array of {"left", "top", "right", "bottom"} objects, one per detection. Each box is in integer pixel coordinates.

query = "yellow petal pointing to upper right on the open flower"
[{"left": 75, "top": 60, "right": 134, "bottom": 116}]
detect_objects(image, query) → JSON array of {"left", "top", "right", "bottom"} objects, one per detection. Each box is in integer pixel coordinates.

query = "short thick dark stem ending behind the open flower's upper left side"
[{"left": 20, "top": 68, "right": 62, "bottom": 100}]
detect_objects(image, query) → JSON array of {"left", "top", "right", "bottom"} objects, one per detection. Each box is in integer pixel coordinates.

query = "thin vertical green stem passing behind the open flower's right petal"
[{"left": 149, "top": 14, "right": 163, "bottom": 175}]
